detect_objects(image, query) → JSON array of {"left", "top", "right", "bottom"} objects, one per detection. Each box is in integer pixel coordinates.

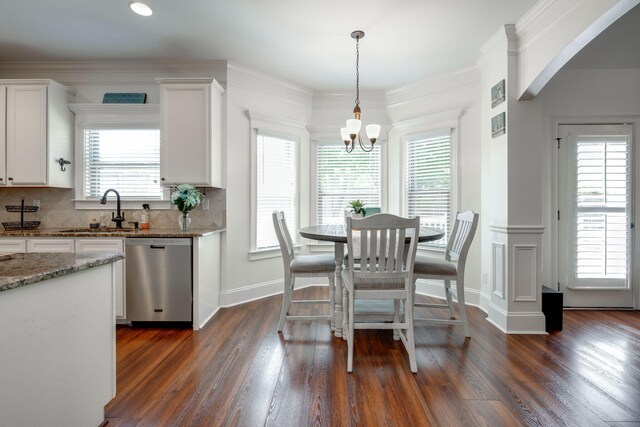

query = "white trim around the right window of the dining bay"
[{"left": 389, "top": 109, "right": 464, "bottom": 253}]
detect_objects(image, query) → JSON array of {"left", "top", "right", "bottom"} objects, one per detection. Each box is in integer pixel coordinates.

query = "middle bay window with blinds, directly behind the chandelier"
[{"left": 317, "top": 144, "right": 381, "bottom": 225}]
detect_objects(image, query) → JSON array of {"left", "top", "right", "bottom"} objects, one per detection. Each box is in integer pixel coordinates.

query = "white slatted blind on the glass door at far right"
[{"left": 575, "top": 136, "right": 631, "bottom": 279}]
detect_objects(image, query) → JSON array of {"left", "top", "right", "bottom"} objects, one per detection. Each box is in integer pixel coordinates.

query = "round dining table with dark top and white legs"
[{"left": 298, "top": 224, "right": 444, "bottom": 338}]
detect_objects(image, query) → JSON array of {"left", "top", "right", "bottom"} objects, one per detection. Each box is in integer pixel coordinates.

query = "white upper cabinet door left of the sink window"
[{"left": 6, "top": 85, "right": 47, "bottom": 185}]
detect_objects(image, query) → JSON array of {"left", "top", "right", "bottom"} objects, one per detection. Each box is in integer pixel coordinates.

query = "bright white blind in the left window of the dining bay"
[{"left": 256, "top": 134, "right": 297, "bottom": 250}]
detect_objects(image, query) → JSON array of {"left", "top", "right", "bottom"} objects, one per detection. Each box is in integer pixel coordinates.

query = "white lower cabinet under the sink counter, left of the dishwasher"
[{"left": 0, "top": 237, "right": 127, "bottom": 319}]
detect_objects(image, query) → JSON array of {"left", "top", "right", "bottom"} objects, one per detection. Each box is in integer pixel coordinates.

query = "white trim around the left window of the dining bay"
[{"left": 246, "top": 110, "right": 309, "bottom": 261}]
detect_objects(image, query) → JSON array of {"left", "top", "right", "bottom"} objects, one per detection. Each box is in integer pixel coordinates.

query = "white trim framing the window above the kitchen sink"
[{"left": 69, "top": 104, "right": 172, "bottom": 210}]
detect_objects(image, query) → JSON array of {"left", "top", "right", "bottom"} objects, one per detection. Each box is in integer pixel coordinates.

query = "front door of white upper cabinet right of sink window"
[{"left": 160, "top": 83, "right": 218, "bottom": 186}]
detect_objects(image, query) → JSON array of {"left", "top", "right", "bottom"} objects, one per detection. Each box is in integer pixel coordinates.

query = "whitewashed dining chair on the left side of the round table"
[{"left": 273, "top": 211, "right": 336, "bottom": 332}]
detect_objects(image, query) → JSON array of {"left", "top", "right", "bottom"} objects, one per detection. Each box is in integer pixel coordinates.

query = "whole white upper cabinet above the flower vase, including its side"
[{"left": 157, "top": 78, "right": 224, "bottom": 187}]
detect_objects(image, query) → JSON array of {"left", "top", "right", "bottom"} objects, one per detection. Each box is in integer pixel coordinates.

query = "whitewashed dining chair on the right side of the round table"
[{"left": 413, "top": 211, "right": 478, "bottom": 337}]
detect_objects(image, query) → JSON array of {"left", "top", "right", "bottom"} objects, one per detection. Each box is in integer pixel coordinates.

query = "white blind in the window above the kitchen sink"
[{"left": 84, "top": 129, "right": 163, "bottom": 200}]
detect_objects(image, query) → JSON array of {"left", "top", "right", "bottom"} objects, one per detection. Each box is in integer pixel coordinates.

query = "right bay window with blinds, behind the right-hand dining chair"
[{"left": 406, "top": 133, "right": 451, "bottom": 247}]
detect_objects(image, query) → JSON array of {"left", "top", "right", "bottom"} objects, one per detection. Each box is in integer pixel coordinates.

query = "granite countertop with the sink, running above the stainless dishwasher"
[{"left": 0, "top": 227, "right": 225, "bottom": 237}]
